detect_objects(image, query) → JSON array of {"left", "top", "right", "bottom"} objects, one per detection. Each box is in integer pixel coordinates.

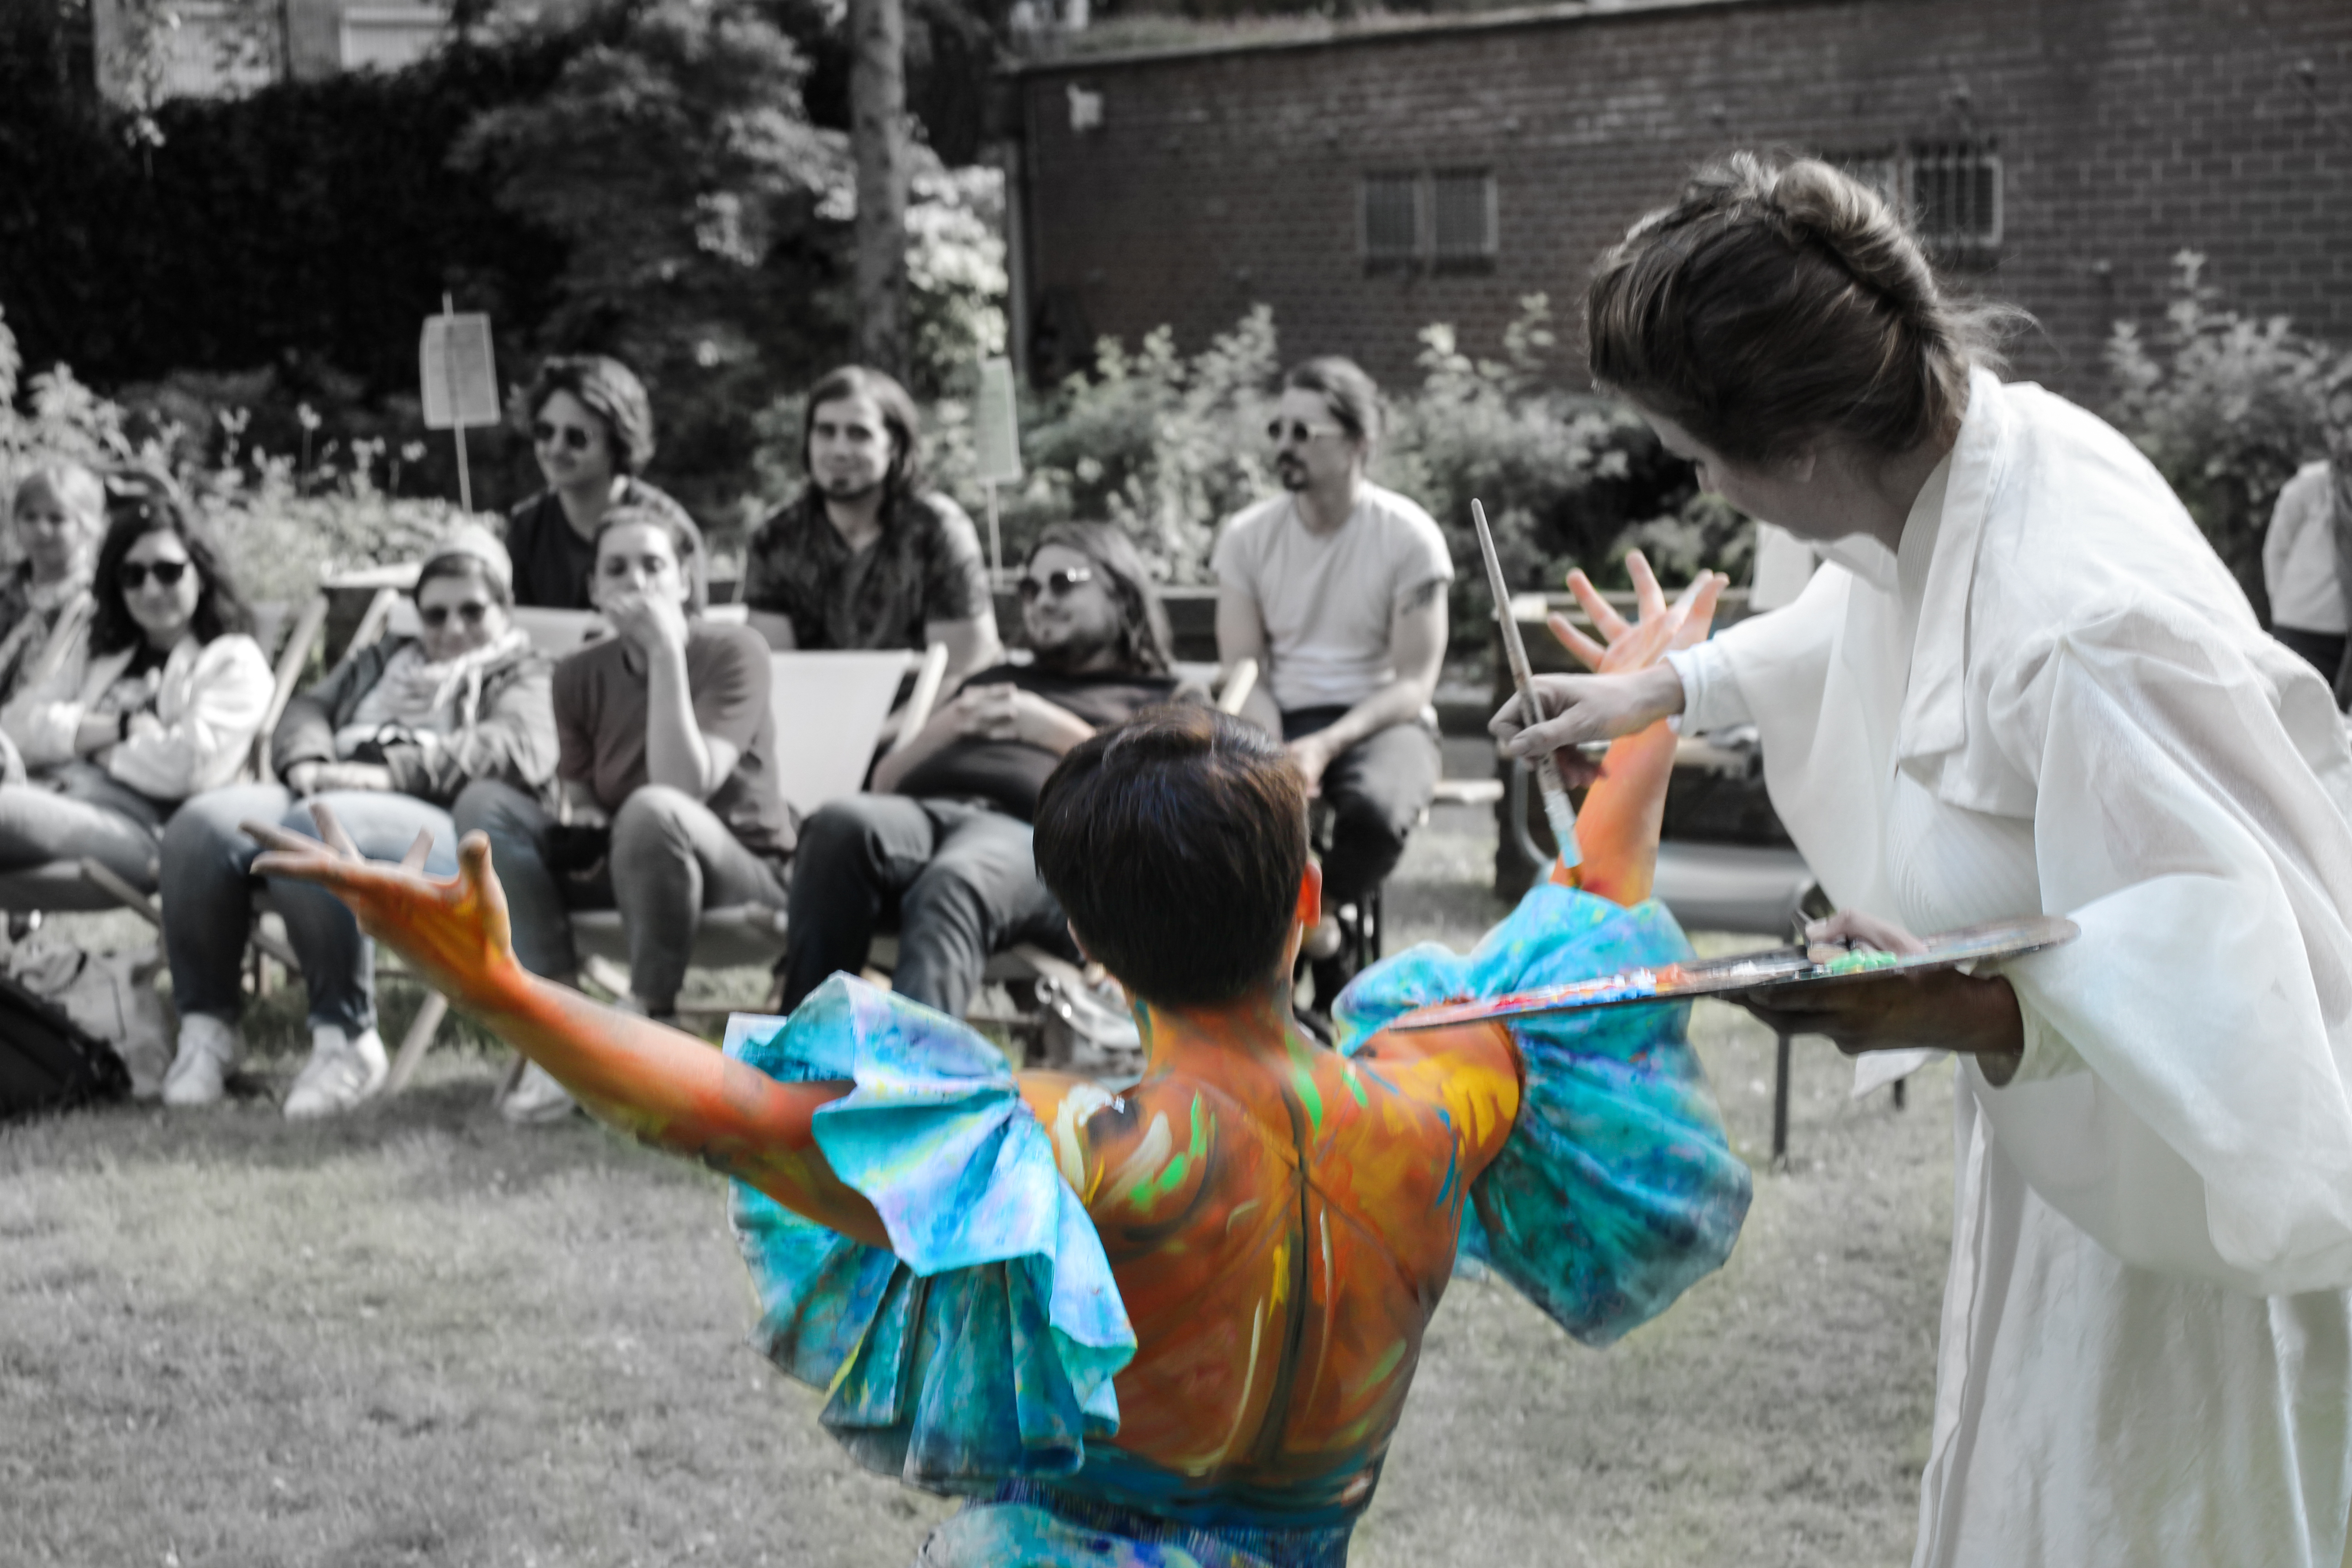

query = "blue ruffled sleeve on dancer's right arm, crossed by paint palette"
[{"left": 1333, "top": 884, "right": 1750, "bottom": 1345}]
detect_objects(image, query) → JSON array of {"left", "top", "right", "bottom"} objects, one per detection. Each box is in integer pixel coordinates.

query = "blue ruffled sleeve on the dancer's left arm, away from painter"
[{"left": 727, "top": 975, "right": 1136, "bottom": 1490}]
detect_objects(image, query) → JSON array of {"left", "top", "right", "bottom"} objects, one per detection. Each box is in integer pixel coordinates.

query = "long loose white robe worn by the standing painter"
[{"left": 1672, "top": 372, "right": 2352, "bottom": 1568}]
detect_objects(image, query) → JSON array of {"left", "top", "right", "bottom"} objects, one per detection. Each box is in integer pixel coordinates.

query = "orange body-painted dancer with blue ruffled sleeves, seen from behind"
[{"left": 256, "top": 557, "right": 1748, "bottom": 1568}]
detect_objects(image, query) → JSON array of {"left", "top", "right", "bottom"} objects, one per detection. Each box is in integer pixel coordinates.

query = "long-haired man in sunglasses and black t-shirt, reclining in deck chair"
[{"left": 783, "top": 522, "right": 1176, "bottom": 1018}]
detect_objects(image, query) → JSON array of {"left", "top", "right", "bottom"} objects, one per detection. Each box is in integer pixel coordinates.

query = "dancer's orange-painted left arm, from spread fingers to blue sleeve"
[{"left": 245, "top": 806, "right": 889, "bottom": 1248}]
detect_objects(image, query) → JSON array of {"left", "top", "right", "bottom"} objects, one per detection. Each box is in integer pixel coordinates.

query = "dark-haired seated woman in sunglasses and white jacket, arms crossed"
[{"left": 0, "top": 475, "right": 273, "bottom": 889}]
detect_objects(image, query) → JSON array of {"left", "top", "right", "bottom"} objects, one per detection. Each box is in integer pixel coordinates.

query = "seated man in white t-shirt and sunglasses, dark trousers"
[{"left": 1214, "top": 358, "right": 1454, "bottom": 1011}]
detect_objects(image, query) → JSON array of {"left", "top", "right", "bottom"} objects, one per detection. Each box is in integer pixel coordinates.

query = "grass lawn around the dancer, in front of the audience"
[{"left": 0, "top": 811, "right": 1950, "bottom": 1568}]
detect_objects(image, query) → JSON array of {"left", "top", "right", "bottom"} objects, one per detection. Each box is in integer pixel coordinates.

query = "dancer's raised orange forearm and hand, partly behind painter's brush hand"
[{"left": 1550, "top": 550, "right": 1731, "bottom": 907}]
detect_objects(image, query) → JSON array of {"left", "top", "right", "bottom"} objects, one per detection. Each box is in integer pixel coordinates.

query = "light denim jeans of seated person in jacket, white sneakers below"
[{"left": 162, "top": 785, "right": 456, "bottom": 1034}]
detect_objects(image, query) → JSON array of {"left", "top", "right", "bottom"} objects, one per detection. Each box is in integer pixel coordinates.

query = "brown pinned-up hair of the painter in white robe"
[{"left": 1585, "top": 153, "right": 2023, "bottom": 466}]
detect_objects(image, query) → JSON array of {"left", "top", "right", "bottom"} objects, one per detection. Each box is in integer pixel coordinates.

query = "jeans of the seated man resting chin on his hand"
[{"left": 451, "top": 778, "right": 785, "bottom": 1015}]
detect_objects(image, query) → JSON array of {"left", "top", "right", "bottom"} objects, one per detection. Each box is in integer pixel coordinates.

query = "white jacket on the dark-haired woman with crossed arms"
[{"left": 0, "top": 635, "right": 275, "bottom": 802}]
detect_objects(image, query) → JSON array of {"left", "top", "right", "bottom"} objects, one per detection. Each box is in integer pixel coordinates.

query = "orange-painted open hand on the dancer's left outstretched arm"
[{"left": 242, "top": 802, "right": 522, "bottom": 1006}]
